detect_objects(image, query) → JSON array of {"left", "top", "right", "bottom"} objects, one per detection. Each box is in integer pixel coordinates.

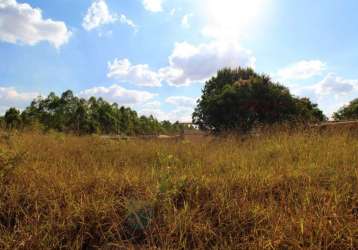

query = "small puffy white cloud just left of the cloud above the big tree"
[{"left": 107, "top": 59, "right": 161, "bottom": 87}]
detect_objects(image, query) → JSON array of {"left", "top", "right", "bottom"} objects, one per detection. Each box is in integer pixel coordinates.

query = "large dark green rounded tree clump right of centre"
[{"left": 193, "top": 68, "right": 326, "bottom": 132}]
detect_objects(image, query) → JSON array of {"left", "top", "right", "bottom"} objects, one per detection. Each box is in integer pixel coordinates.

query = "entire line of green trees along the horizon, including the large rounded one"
[{"left": 0, "top": 68, "right": 358, "bottom": 135}]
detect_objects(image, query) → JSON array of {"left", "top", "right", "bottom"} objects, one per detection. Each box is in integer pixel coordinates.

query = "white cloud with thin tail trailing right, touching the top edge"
[{"left": 82, "top": 0, "right": 137, "bottom": 31}]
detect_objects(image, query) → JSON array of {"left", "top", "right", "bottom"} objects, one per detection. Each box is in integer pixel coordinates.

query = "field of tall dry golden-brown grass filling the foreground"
[{"left": 0, "top": 132, "right": 358, "bottom": 249}]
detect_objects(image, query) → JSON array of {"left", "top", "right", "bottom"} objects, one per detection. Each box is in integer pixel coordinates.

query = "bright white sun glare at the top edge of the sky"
[{"left": 203, "top": 0, "right": 268, "bottom": 38}]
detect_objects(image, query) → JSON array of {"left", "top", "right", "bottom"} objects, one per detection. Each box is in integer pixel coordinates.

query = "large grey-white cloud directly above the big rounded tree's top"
[{"left": 159, "top": 42, "right": 256, "bottom": 86}]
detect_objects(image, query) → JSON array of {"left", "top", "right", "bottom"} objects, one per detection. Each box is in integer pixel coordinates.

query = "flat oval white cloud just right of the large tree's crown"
[{"left": 275, "top": 60, "right": 326, "bottom": 81}]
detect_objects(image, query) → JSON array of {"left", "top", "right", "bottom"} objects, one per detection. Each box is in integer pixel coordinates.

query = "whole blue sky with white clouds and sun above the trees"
[{"left": 0, "top": 0, "right": 358, "bottom": 122}]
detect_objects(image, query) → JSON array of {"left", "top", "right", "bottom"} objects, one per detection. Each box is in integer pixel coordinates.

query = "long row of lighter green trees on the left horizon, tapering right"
[{"left": 1, "top": 90, "right": 190, "bottom": 135}]
